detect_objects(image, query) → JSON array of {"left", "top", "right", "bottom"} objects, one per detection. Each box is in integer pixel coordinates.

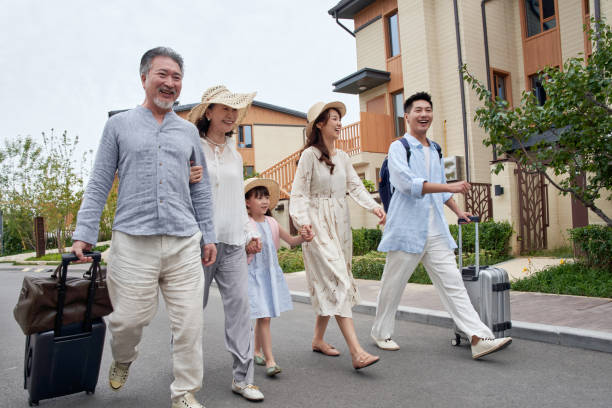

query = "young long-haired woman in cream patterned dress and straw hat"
[{"left": 289, "top": 102, "right": 386, "bottom": 369}]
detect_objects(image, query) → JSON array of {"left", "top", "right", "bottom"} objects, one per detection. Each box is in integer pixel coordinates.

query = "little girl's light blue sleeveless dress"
[{"left": 248, "top": 221, "right": 293, "bottom": 319}]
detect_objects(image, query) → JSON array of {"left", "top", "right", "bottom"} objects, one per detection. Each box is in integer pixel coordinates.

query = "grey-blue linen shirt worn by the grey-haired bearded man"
[{"left": 72, "top": 105, "right": 216, "bottom": 245}]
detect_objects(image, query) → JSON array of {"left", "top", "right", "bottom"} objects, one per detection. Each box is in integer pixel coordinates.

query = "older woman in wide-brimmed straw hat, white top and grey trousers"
[{"left": 188, "top": 85, "right": 264, "bottom": 401}]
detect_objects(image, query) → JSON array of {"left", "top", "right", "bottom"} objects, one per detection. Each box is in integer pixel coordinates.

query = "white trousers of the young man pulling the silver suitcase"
[{"left": 372, "top": 235, "right": 494, "bottom": 339}]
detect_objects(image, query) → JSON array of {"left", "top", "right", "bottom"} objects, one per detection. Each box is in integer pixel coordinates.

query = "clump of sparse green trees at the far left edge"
[{"left": 0, "top": 129, "right": 91, "bottom": 252}]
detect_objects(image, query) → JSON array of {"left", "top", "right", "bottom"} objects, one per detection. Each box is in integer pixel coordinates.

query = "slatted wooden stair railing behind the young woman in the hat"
[{"left": 259, "top": 122, "right": 361, "bottom": 199}]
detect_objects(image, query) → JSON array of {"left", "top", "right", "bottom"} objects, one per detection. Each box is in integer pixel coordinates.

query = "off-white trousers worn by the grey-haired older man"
[{"left": 107, "top": 231, "right": 204, "bottom": 398}]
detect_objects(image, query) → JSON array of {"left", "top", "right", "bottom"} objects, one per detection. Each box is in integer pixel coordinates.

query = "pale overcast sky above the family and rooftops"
[{"left": 0, "top": 0, "right": 359, "bottom": 161}]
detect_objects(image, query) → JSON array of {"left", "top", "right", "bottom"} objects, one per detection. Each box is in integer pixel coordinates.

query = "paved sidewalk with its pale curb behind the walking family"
[{"left": 285, "top": 270, "right": 612, "bottom": 353}]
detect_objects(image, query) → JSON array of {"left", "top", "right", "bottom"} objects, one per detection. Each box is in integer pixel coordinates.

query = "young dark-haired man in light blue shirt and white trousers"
[{"left": 372, "top": 92, "right": 512, "bottom": 359}]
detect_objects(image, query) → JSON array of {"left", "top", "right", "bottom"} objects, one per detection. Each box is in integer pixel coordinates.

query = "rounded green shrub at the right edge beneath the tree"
[{"left": 569, "top": 225, "right": 612, "bottom": 271}]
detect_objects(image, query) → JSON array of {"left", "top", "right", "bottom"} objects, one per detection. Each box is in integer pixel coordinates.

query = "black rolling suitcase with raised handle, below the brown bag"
[{"left": 24, "top": 252, "right": 106, "bottom": 406}]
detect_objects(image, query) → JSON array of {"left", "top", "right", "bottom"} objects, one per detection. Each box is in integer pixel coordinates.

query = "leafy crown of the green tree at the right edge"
[{"left": 463, "top": 20, "right": 612, "bottom": 225}]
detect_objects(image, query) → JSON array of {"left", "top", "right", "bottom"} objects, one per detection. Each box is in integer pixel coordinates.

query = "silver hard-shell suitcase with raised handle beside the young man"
[{"left": 451, "top": 217, "right": 512, "bottom": 346}]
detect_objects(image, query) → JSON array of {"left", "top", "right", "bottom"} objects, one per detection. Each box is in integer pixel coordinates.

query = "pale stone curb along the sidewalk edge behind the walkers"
[{"left": 291, "top": 291, "right": 612, "bottom": 353}]
